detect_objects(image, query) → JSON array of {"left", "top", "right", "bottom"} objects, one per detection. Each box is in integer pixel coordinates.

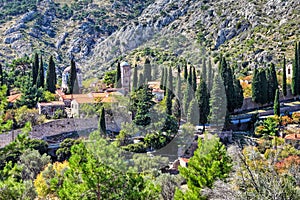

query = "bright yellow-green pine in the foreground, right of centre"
[{"left": 175, "top": 136, "right": 232, "bottom": 200}]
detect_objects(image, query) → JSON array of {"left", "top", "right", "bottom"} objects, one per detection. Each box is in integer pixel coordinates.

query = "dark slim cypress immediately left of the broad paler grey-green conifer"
[{"left": 196, "top": 77, "right": 209, "bottom": 131}]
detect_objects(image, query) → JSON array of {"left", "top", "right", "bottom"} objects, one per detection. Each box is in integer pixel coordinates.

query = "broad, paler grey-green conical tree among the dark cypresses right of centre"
[{"left": 209, "top": 74, "right": 228, "bottom": 127}]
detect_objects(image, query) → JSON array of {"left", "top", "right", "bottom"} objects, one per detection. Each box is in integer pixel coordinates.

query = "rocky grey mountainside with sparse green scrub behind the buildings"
[{"left": 0, "top": 0, "right": 300, "bottom": 77}]
